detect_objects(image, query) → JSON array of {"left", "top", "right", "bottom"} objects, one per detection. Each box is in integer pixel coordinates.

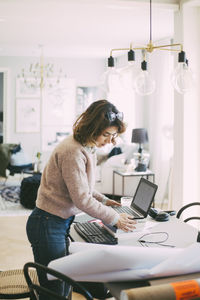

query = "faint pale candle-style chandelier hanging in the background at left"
[{"left": 18, "top": 45, "right": 67, "bottom": 90}]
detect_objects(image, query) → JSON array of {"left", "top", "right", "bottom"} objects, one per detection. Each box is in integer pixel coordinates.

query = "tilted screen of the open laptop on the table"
[{"left": 131, "top": 178, "right": 158, "bottom": 215}]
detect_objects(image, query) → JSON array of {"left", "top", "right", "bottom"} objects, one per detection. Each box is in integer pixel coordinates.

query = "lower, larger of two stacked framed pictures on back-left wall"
[{"left": 16, "top": 98, "right": 40, "bottom": 133}]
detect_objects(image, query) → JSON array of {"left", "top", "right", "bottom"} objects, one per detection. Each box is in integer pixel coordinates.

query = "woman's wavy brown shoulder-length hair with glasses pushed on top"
[{"left": 73, "top": 100, "right": 126, "bottom": 145}]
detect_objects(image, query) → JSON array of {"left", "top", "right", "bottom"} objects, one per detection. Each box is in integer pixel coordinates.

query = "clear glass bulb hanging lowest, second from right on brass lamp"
[{"left": 134, "top": 70, "right": 156, "bottom": 96}]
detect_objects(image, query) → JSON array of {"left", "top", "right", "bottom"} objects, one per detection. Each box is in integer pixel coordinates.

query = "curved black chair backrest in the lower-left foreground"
[{"left": 24, "top": 262, "right": 93, "bottom": 300}]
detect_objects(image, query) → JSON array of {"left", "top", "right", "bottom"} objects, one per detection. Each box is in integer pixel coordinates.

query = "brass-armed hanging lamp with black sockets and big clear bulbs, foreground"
[{"left": 102, "top": 0, "right": 193, "bottom": 96}]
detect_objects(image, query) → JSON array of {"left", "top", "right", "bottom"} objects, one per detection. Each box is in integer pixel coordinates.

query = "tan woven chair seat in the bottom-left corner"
[{"left": 0, "top": 269, "right": 38, "bottom": 299}]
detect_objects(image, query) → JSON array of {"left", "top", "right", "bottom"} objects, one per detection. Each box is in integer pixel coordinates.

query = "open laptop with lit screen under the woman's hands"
[{"left": 113, "top": 177, "right": 158, "bottom": 219}]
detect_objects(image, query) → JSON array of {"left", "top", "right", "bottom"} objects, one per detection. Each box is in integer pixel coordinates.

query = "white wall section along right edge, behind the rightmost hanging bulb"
[{"left": 172, "top": 0, "right": 200, "bottom": 213}]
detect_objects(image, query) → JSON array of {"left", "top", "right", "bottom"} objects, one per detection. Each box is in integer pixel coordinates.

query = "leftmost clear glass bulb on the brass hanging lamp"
[{"left": 101, "top": 67, "right": 122, "bottom": 92}]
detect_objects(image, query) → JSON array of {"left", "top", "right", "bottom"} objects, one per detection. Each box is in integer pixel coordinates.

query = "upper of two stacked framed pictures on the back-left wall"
[{"left": 16, "top": 77, "right": 40, "bottom": 98}]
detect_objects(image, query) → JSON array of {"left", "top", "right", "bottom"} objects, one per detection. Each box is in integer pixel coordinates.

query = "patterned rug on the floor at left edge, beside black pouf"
[{"left": 0, "top": 184, "right": 32, "bottom": 216}]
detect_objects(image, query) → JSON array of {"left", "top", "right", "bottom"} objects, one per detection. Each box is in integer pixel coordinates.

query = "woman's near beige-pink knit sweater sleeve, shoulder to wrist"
[{"left": 61, "top": 145, "right": 117, "bottom": 223}]
